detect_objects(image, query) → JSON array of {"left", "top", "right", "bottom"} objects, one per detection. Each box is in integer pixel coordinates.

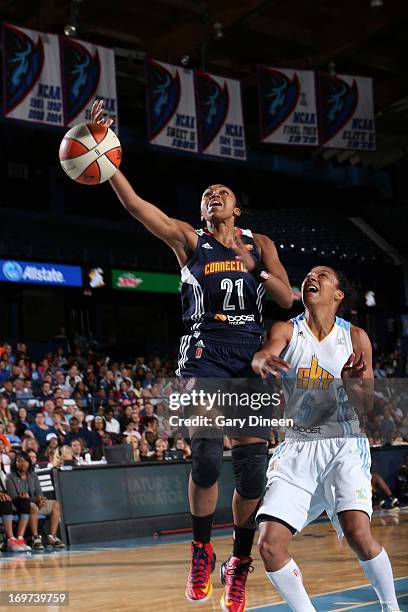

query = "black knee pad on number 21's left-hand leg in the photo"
[{"left": 191, "top": 437, "right": 224, "bottom": 488}]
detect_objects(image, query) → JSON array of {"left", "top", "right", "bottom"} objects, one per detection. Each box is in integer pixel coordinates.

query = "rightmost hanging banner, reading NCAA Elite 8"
[{"left": 319, "top": 74, "right": 375, "bottom": 151}]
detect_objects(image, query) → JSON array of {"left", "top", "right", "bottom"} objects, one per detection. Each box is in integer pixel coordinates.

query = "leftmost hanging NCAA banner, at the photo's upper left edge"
[{"left": 3, "top": 24, "right": 64, "bottom": 125}]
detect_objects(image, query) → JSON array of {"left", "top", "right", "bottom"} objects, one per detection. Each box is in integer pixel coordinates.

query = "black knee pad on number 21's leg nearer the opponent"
[{"left": 231, "top": 442, "right": 268, "bottom": 499}]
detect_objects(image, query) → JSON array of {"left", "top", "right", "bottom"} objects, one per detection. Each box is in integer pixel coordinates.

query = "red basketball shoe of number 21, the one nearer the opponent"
[{"left": 220, "top": 557, "right": 254, "bottom": 612}]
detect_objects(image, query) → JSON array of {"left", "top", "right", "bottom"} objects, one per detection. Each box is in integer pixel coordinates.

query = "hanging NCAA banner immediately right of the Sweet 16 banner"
[{"left": 196, "top": 70, "right": 246, "bottom": 160}]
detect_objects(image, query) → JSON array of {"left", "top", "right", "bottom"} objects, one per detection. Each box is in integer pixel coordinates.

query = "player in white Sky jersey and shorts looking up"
[{"left": 252, "top": 266, "right": 399, "bottom": 612}]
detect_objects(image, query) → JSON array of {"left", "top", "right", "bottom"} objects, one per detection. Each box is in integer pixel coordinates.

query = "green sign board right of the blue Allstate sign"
[{"left": 112, "top": 269, "right": 180, "bottom": 293}]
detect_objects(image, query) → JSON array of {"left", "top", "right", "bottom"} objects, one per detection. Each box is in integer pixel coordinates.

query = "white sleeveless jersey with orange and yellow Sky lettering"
[{"left": 282, "top": 313, "right": 360, "bottom": 439}]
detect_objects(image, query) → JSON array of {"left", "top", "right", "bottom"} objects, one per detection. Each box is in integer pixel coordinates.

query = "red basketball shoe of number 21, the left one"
[{"left": 186, "top": 542, "right": 215, "bottom": 603}]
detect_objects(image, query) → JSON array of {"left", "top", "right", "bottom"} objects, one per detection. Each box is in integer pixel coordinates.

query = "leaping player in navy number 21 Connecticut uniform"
[{"left": 92, "top": 102, "right": 292, "bottom": 612}]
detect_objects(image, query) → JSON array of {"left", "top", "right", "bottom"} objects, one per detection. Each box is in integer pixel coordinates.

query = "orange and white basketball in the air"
[{"left": 59, "top": 123, "right": 122, "bottom": 185}]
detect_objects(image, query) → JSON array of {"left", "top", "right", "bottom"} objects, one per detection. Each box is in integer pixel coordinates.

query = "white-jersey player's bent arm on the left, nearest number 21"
[{"left": 252, "top": 321, "right": 293, "bottom": 378}]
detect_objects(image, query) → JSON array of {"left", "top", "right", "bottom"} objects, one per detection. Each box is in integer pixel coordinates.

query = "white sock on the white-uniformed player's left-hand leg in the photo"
[{"left": 266, "top": 559, "right": 316, "bottom": 612}]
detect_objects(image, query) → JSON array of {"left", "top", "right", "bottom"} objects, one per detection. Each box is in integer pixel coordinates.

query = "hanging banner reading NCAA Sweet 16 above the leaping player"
[{"left": 146, "top": 59, "right": 198, "bottom": 153}]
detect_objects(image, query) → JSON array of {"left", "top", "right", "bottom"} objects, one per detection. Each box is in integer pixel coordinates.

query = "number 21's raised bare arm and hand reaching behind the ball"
[{"left": 91, "top": 100, "right": 195, "bottom": 253}]
